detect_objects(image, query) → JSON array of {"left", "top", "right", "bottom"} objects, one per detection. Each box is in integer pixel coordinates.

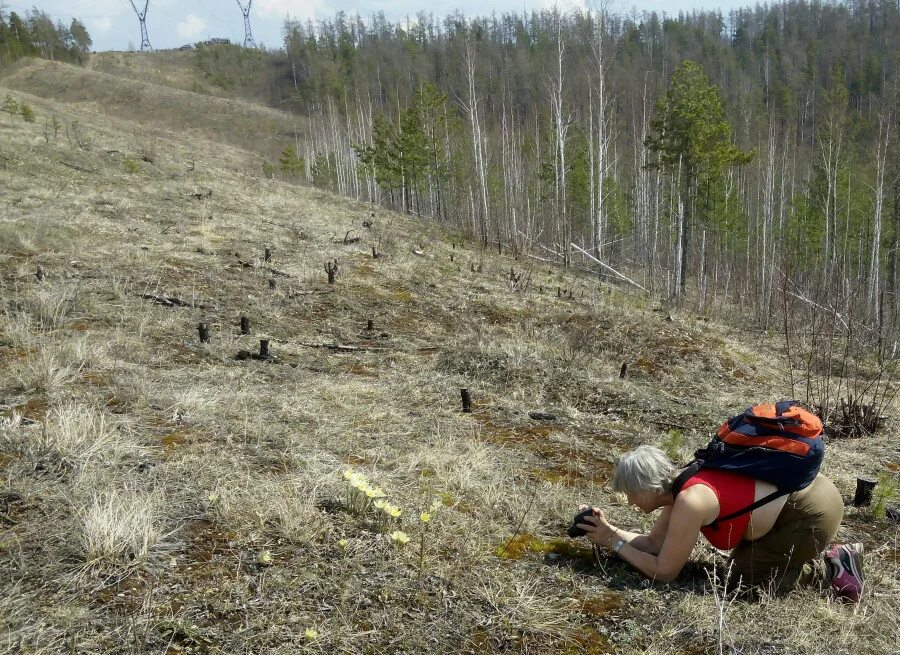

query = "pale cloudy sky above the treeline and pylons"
[{"left": 0, "top": 0, "right": 754, "bottom": 51}]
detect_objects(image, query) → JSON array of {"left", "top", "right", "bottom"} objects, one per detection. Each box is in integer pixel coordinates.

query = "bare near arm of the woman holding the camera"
[{"left": 583, "top": 492, "right": 710, "bottom": 582}]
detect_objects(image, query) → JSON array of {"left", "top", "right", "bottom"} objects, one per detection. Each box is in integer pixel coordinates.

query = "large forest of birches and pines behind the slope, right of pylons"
[{"left": 220, "top": 0, "right": 900, "bottom": 336}]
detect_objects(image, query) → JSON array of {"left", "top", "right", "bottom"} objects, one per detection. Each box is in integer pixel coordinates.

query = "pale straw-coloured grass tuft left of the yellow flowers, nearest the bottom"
[{"left": 77, "top": 490, "right": 161, "bottom": 573}]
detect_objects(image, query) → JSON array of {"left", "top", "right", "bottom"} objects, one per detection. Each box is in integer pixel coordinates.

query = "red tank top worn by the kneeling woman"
[{"left": 681, "top": 469, "right": 756, "bottom": 550}]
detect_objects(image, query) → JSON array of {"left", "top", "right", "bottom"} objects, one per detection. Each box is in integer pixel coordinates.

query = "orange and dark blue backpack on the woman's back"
[{"left": 672, "top": 400, "right": 825, "bottom": 525}]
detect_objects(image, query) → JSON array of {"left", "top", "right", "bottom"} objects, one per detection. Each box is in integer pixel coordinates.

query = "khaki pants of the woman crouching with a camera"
[{"left": 730, "top": 474, "right": 844, "bottom": 593}]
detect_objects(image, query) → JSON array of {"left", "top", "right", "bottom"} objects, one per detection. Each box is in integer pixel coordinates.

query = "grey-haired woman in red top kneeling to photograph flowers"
[{"left": 579, "top": 446, "right": 863, "bottom": 602}]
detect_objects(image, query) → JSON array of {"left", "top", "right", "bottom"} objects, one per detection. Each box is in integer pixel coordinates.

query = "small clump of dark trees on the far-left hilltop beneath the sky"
[{"left": 0, "top": 3, "right": 92, "bottom": 69}]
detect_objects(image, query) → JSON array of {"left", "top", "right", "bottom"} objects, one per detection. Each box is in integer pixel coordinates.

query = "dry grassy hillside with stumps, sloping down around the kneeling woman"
[{"left": 0, "top": 62, "right": 900, "bottom": 655}]
